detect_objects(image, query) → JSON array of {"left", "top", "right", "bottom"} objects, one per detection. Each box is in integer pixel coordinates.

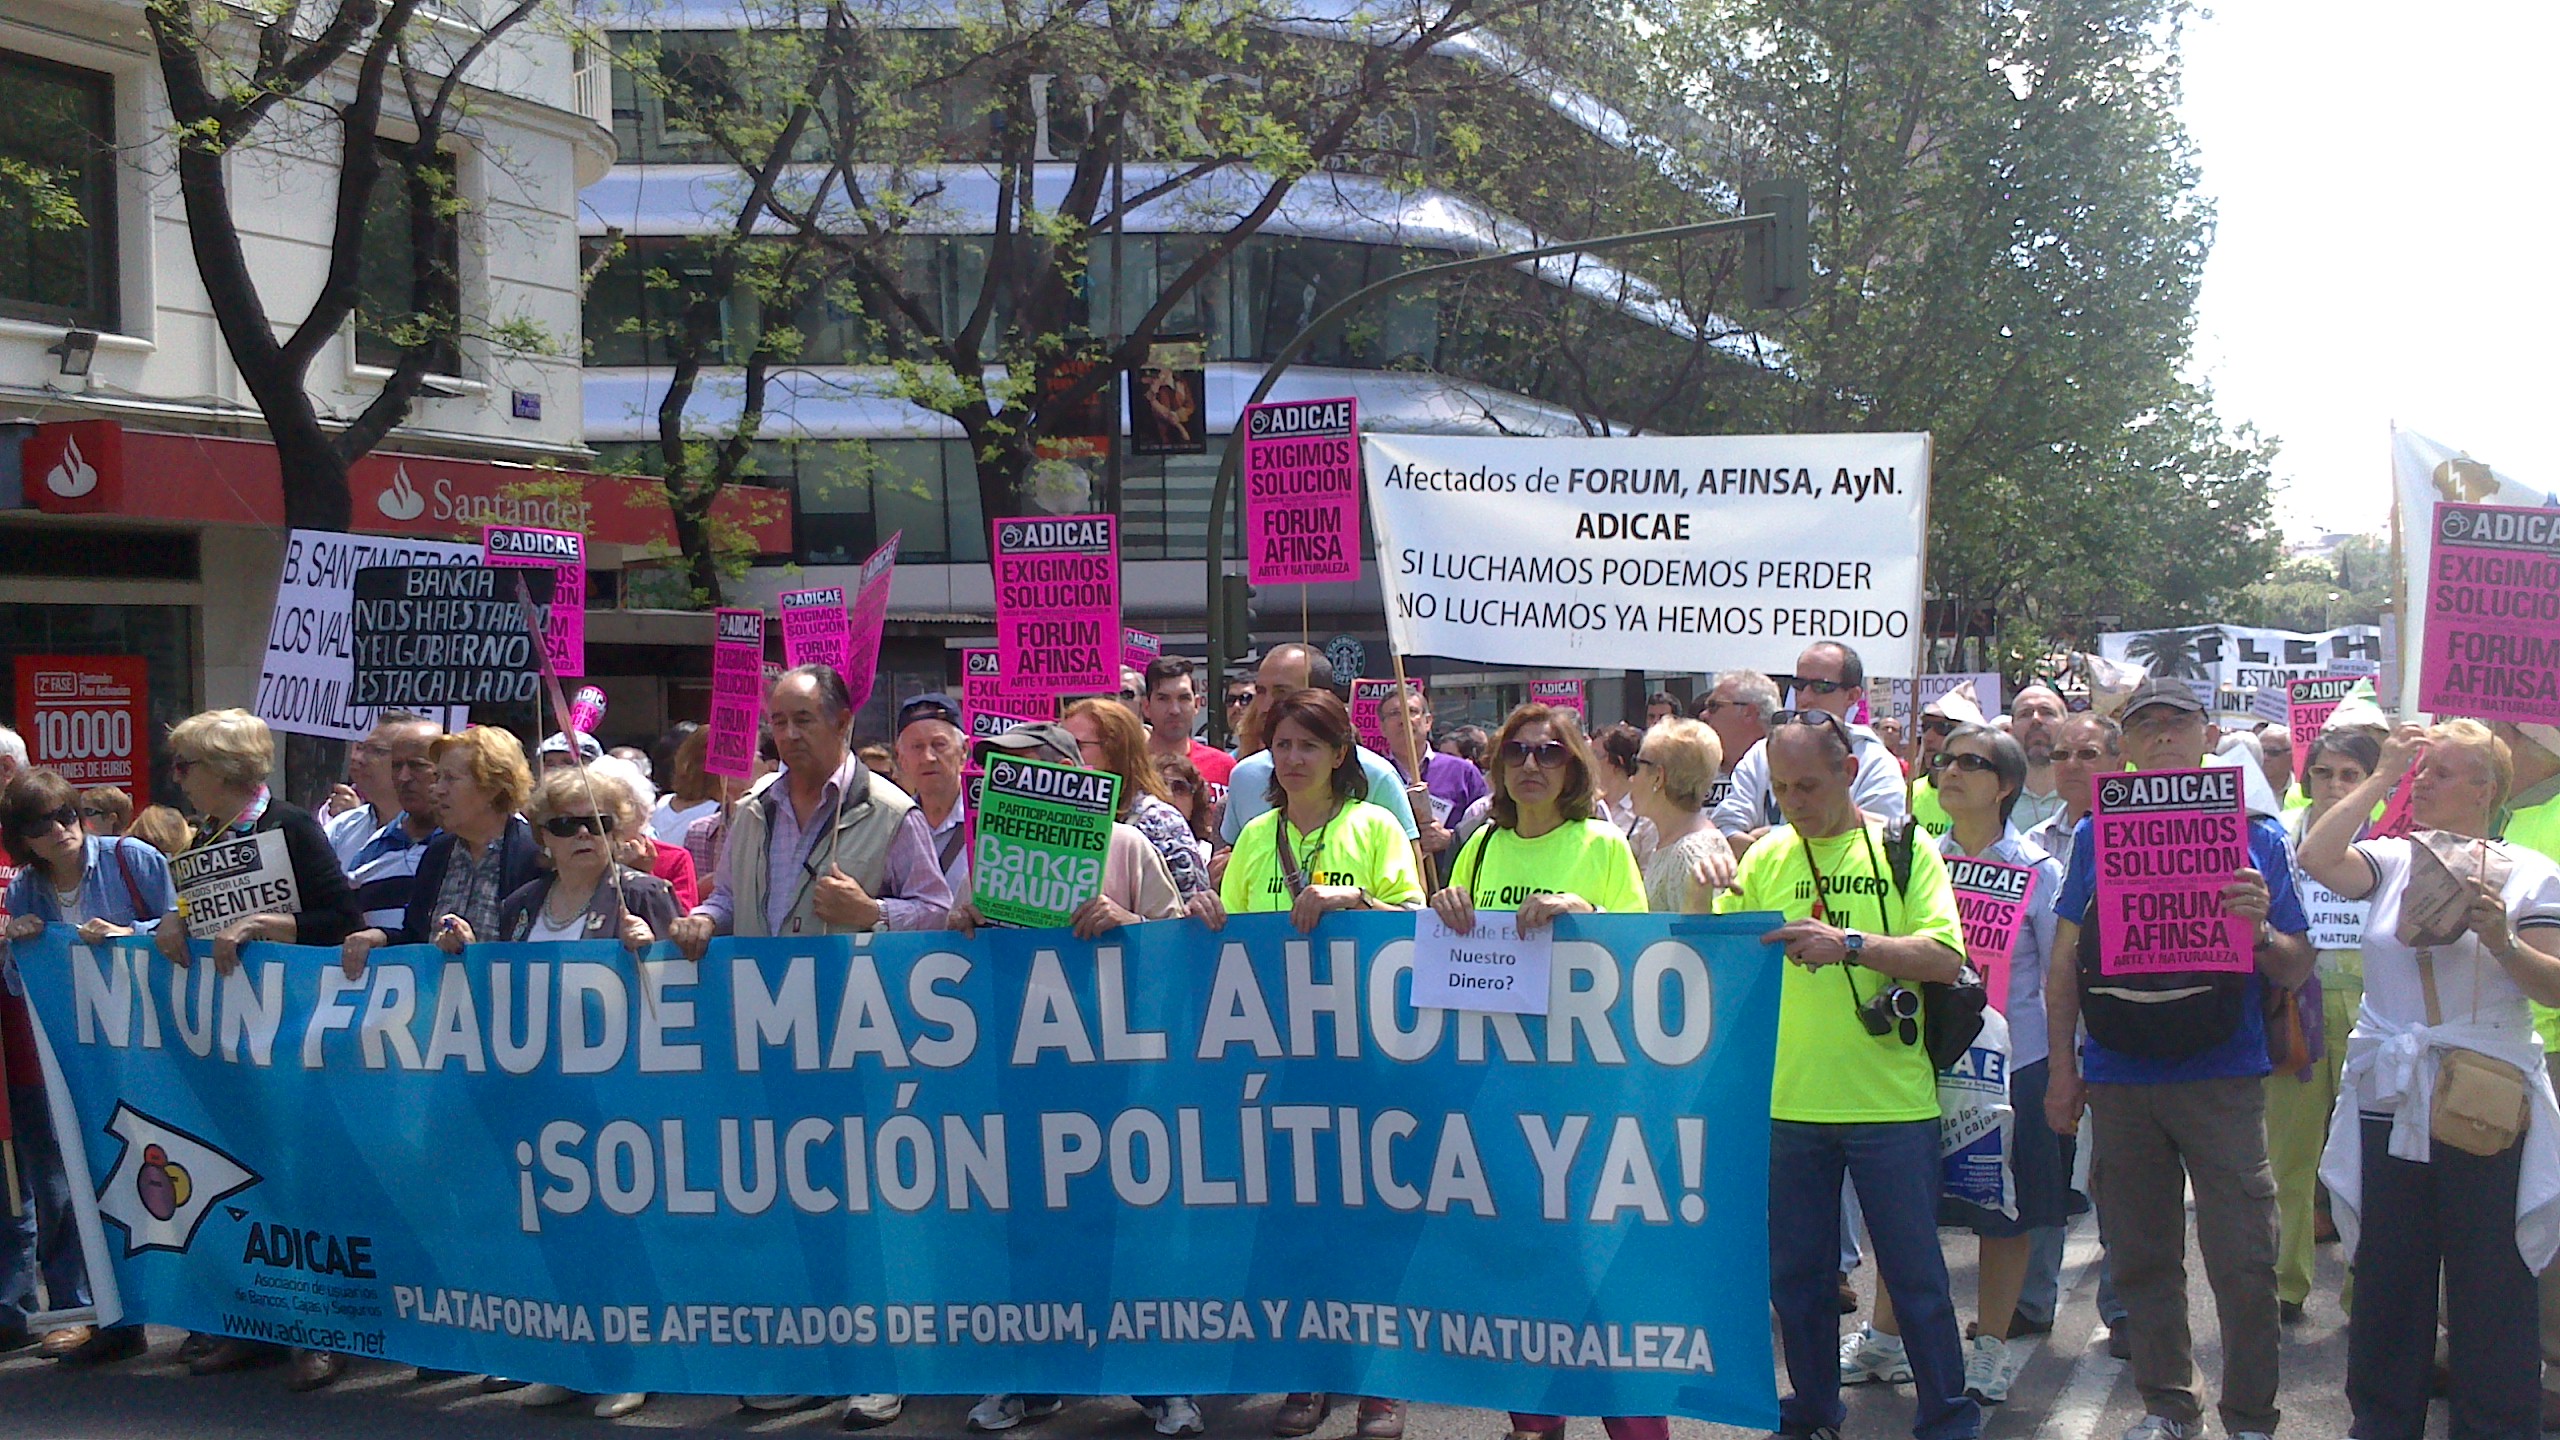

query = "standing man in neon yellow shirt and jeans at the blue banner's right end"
[{"left": 1723, "top": 710, "right": 1981, "bottom": 1440}]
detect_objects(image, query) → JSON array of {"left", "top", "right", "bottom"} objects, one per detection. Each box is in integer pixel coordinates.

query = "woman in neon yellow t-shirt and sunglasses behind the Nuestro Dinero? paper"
[{"left": 1431, "top": 705, "right": 1646, "bottom": 933}]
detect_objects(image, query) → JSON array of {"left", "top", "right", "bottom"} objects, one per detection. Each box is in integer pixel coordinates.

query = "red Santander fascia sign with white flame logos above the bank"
[{"left": 20, "top": 420, "right": 791, "bottom": 553}]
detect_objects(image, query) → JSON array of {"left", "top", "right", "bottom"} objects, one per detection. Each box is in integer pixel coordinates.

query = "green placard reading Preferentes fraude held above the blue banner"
[{"left": 970, "top": 756, "right": 1119, "bottom": 925}]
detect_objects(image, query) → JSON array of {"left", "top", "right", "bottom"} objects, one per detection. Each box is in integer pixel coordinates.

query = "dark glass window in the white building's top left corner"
[{"left": 0, "top": 51, "right": 118, "bottom": 331}]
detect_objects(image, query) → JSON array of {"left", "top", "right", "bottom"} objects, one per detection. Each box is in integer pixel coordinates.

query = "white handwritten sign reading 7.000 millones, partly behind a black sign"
[{"left": 256, "top": 530, "right": 481, "bottom": 740}]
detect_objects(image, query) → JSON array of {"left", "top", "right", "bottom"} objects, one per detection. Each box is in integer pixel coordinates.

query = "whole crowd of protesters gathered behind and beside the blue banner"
[{"left": 0, "top": 643, "right": 2560, "bottom": 1440}]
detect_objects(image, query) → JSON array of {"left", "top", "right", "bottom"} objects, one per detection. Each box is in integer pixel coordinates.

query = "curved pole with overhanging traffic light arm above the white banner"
[{"left": 1206, "top": 182, "right": 1807, "bottom": 738}]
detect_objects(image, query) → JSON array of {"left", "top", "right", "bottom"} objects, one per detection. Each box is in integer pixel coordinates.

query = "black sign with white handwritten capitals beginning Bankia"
[{"left": 351, "top": 566, "right": 553, "bottom": 710}]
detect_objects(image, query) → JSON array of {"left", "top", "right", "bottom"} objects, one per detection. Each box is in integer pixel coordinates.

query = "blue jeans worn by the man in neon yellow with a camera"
[{"left": 1769, "top": 1120, "right": 1981, "bottom": 1440}]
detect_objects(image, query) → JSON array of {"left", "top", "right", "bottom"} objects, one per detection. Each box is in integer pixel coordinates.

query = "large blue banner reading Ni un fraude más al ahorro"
[{"left": 15, "top": 915, "right": 1777, "bottom": 1427}]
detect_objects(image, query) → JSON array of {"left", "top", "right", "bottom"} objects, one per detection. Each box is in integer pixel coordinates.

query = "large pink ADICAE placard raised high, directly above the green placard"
[{"left": 988, "top": 515, "right": 1121, "bottom": 694}]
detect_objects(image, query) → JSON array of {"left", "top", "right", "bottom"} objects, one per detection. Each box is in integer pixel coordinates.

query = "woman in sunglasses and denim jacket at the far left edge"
[{"left": 0, "top": 769, "right": 177, "bottom": 1366}]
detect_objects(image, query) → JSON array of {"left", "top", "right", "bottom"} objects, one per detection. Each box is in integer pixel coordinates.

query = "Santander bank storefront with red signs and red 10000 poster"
[{"left": 0, "top": 420, "right": 791, "bottom": 792}]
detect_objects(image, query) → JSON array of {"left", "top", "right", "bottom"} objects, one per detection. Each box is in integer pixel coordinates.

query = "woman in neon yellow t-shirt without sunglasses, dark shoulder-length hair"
[{"left": 1193, "top": 689, "right": 1423, "bottom": 930}]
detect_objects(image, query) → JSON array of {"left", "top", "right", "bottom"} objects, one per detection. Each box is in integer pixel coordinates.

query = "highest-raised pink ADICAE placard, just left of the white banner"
[{"left": 1244, "top": 397, "right": 1359, "bottom": 584}]
